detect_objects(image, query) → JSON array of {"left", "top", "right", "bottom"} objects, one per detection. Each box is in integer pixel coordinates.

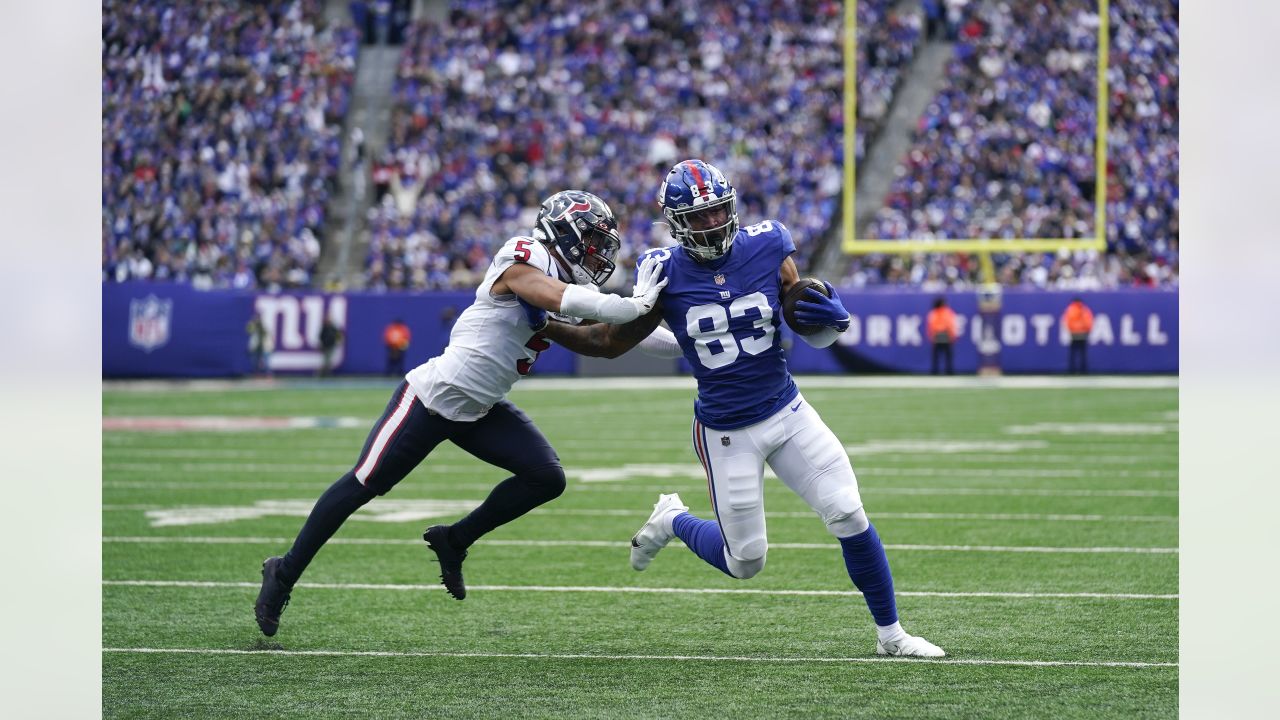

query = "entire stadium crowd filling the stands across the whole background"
[{"left": 102, "top": 0, "right": 1178, "bottom": 290}]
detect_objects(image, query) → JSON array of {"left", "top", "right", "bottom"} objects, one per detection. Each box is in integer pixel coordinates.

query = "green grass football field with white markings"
[{"left": 102, "top": 378, "right": 1179, "bottom": 717}]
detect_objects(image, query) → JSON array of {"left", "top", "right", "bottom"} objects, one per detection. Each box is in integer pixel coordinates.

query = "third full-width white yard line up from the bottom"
[{"left": 102, "top": 536, "right": 1178, "bottom": 555}]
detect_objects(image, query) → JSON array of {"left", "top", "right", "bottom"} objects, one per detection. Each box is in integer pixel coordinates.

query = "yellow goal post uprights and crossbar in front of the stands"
[{"left": 841, "top": 0, "right": 1110, "bottom": 255}]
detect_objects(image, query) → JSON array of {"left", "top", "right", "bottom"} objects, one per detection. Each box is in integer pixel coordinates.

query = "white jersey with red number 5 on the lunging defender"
[{"left": 404, "top": 237, "right": 564, "bottom": 421}]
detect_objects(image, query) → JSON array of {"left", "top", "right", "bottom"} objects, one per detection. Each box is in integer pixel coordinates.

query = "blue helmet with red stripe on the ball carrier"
[{"left": 658, "top": 160, "right": 737, "bottom": 263}]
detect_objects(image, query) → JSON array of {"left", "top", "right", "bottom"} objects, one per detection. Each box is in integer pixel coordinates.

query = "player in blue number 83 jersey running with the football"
[{"left": 527, "top": 160, "right": 943, "bottom": 657}]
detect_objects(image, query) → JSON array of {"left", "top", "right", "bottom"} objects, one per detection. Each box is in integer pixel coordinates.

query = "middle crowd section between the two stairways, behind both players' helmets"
[{"left": 366, "top": 0, "right": 922, "bottom": 288}]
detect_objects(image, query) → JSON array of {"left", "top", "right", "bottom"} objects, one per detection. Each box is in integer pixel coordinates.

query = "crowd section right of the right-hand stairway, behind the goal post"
[{"left": 847, "top": 0, "right": 1178, "bottom": 290}]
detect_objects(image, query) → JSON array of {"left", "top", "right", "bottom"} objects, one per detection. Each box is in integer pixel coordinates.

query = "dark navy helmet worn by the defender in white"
[{"left": 534, "top": 190, "right": 622, "bottom": 286}]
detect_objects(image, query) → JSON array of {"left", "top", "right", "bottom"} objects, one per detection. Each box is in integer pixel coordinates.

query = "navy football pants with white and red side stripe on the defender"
[{"left": 280, "top": 382, "right": 564, "bottom": 584}]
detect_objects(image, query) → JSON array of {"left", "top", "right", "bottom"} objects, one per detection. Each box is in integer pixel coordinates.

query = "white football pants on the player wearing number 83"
[{"left": 694, "top": 395, "right": 867, "bottom": 578}]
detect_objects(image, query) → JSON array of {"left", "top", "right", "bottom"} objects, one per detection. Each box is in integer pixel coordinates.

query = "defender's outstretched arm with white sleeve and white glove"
[{"left": 493, "top": 252, "right": 667, "bottom": 323}]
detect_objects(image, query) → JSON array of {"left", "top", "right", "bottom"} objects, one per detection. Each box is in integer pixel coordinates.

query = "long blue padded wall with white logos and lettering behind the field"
[{"left": 102, "top": 283, "right": 1179, "bottom": 378}]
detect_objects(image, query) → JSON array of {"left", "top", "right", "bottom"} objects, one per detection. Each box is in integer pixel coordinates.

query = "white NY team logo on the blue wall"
[{"left": 253, "top": 295, "right": 347, "bottom": 373}]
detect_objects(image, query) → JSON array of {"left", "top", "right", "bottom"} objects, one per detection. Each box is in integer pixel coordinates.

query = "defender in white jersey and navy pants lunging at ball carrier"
[{"left": 253, "top": 190, "right": 664, "bottom": 635}]
